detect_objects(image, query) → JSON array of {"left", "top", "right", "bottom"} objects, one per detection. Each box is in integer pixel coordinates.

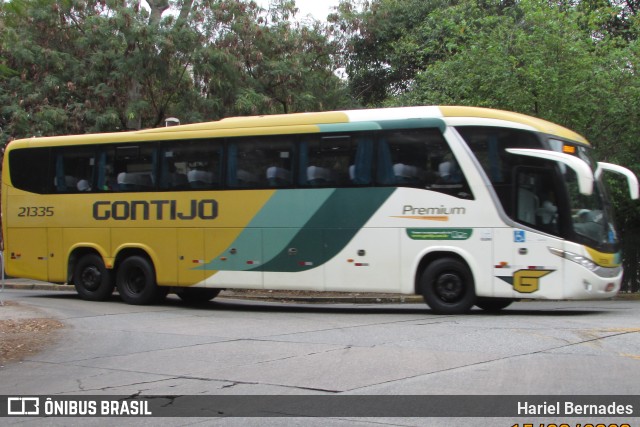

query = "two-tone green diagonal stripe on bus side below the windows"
[{"left": 197, "top": 188, "right": 395, "bottom": 272}]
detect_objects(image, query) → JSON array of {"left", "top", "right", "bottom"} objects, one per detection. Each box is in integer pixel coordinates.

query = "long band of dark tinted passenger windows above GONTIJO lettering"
[{"left": 10, "top": 128, "right": 464, "bottom": 198}]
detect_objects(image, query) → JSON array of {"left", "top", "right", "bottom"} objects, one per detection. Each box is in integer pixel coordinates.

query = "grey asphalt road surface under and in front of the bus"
[{"left": 0, "top": 289, "right": 640, "bottom": 426}]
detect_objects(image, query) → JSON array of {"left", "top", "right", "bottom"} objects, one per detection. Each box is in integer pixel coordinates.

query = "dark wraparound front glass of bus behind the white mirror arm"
[{"left": 456, "top": 126, "right": 618, "bottom": 252}]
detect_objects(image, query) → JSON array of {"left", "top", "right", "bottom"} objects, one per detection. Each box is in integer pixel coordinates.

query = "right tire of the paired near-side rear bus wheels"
[{"left": 116, "top": 256, "right": 162, "bottom": 305}]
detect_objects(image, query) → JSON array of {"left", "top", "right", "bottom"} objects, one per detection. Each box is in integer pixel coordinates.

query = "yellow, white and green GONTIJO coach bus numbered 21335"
[{"left": 2, "top": 106, "right": 638, "bottom": 314}]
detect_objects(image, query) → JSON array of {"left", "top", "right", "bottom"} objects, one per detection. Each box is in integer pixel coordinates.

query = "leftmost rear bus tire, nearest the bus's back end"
[{"left": 73, "top": 254, "right": 114, "bottom": 301}]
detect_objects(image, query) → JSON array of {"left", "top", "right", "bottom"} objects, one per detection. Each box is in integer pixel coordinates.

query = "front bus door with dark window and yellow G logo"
[{"left": 494, "top": 167, "right": 564, "bottom": 298}]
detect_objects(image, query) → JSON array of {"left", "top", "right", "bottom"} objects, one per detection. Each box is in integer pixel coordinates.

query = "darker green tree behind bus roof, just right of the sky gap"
[{"left": 331, "top": 0, "right": 512, "bottom": 106}]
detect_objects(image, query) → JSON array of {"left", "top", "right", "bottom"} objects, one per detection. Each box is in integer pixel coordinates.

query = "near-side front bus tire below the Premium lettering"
[{"left": 420, "top": 258, "right": 476, "bottom": 314}]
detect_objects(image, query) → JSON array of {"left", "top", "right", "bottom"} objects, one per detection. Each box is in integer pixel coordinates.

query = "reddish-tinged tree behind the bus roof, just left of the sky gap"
[{"left": 194, "top": 0, "right": 348, "bottom": 114}]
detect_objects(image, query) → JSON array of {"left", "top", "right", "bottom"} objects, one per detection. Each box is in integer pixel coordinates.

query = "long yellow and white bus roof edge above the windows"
[{"left": 6, "top": 106, "right": 589, "bottom": 148}]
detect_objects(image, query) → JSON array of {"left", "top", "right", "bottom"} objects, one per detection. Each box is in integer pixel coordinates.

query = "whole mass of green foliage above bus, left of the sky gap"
[{"left": 0, "top": 0, "right": 348, "bottom": 143}]
